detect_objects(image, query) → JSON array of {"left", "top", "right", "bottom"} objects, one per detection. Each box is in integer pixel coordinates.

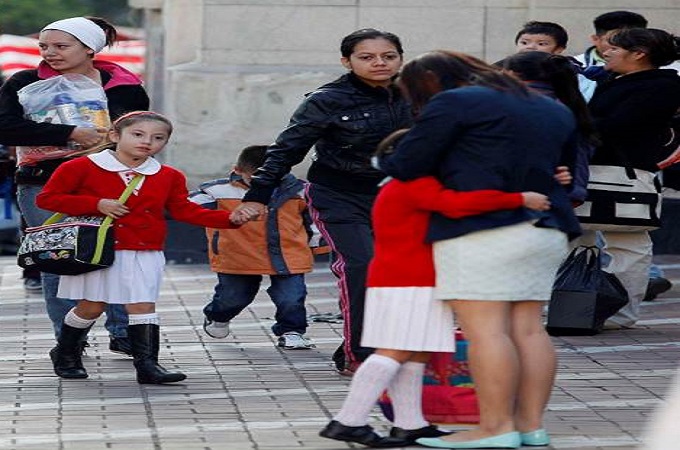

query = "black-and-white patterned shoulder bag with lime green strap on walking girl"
[{"left": 17, "top": 174, "right": 144, "bottom": 275}]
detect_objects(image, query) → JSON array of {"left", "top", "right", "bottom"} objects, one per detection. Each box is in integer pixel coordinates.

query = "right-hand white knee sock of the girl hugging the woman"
[{"left": 388, "top": 361, "right": 429, "bottom": 430}]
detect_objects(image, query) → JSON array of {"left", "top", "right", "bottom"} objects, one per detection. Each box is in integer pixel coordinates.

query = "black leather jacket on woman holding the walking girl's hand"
[{"left": 244, "top": 73, "right": 412, "bottom": 204}]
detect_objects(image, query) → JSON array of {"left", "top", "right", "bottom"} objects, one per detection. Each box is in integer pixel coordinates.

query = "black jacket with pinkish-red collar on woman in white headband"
[{"left": 0, "top": 60, "right": 149, "bottom": 184}]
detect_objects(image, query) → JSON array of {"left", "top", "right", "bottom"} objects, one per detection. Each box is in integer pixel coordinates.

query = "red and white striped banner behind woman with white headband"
[{"left": 0, "top": 34, "right": 146, "bottom": 77}]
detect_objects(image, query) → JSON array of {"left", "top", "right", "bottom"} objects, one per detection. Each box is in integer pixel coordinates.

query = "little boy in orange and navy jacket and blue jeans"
[{"left": 189, "top": 145, "right": 314, "bottom": 350}]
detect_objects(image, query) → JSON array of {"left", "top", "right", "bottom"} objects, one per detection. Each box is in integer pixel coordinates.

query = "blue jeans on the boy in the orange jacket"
[{"left": 203, "top": 273, "right": 307, "bottom": 336}]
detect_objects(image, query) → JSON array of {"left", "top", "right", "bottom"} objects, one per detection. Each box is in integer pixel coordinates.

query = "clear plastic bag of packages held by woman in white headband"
[{"left": 17, "top": 74, "right": 111, "bottom": 166}]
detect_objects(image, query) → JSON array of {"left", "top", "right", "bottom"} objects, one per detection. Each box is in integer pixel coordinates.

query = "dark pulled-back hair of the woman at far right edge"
[{"left": 607, "top": 28, "right": 680, "bottom": 67}]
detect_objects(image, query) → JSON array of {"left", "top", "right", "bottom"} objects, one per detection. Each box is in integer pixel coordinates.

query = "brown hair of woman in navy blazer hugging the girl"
[{"left": 399, "top": 50, "right": 528, "bottom": 112}]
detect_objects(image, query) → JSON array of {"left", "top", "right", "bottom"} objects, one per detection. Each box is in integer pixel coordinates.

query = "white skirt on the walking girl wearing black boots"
[{"left": 57, "top": 250, "right": 165, "bottom": 304}]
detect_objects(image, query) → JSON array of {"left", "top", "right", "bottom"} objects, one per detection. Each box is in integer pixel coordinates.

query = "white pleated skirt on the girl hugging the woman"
[{"left": 361, "top": 287, "right": 456, "bottom": 352}]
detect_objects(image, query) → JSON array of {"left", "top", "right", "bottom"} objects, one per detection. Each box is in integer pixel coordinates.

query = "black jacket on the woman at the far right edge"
[{"left": 588, "top": 69, "right": 680, "bottom": 172}]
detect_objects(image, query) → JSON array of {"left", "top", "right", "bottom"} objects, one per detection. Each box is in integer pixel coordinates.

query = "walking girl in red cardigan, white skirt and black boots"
[{"left": 37, "top": 111, "right": 241, "bottom": 384}]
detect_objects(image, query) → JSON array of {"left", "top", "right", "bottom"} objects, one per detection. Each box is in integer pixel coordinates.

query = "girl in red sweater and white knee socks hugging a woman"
[{"left": 320, "top": 130, "right": 552, "bottom": 448}]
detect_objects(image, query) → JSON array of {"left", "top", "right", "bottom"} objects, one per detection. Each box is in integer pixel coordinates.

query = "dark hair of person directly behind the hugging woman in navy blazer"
[{"left": 503, "top": 52, "right": 599, "bottom": 145}]
